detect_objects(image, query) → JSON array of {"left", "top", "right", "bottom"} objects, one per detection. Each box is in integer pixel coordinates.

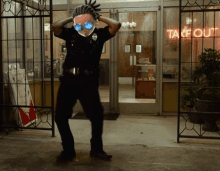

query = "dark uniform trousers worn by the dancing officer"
[{"left": 55, "top": 74, "right": 103, "bottom": 152}]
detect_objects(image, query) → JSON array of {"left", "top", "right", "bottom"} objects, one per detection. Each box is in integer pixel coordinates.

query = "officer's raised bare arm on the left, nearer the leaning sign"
[{"left": 51, "top": 17, "right": 73, "bottom": 36}]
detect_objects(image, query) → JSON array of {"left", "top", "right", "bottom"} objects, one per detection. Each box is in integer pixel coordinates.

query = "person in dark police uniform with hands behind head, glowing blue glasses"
[{"left": 51, "top": 0, "right": 121, "bottom": 160}]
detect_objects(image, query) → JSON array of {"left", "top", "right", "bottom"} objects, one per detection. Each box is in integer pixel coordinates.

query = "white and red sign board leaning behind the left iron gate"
[{"left": 6, "top": 69, "right": 37, "bottom": 127}]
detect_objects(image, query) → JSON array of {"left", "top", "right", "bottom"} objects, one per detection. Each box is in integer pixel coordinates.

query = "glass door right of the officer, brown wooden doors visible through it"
[{"left": 117, "top": 8, "right": 160, "bottom": 113}]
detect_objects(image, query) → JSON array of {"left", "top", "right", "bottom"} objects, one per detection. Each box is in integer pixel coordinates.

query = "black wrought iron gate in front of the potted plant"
[{"left": 176, "top": 0, "right": 220, "bottom": 142}]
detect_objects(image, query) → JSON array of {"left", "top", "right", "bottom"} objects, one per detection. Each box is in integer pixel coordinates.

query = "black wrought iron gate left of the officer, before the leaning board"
[{"left": 0, "top": 0, "right": 55, "bottom": 136}]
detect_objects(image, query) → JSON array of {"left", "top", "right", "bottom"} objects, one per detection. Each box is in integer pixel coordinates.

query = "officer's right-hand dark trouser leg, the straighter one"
[{"left": 79, "top": 79, "right": 103, "bottom": 152}]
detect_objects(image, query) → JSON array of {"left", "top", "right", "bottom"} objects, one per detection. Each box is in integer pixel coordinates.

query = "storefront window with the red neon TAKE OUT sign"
[{"left": 163, "top": 7, "right": 220, "bottom": 81}]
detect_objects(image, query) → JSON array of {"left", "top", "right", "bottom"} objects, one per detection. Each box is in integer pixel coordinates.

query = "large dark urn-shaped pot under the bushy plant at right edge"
[{"left": 196, "top": 98, "right": 220, "bottom": 132}]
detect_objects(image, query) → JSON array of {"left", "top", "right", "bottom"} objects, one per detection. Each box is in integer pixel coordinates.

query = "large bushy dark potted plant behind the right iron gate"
[{"left": 181, "top": 48, "right": 220, "bottom": 132}]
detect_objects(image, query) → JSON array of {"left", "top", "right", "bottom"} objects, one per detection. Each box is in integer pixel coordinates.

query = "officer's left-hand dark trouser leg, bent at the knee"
[{"left": 55, "top": 78, "right": 77, "bottom": 151}]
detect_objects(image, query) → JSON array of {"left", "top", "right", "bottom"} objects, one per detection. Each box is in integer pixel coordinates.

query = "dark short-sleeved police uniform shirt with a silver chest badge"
[{"left": 54, "top": 26, "right": 115, "bottom": 69}]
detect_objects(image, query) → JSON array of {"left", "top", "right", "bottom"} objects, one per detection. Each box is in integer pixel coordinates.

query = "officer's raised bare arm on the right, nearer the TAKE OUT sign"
[{"left": 99, "top": 16, "right": 121, "bottom": 35}]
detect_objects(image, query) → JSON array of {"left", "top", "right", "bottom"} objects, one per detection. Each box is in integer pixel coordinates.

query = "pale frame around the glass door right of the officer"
[{"left": 110, "top": 7, "right": 162, "bottom": 115}]
